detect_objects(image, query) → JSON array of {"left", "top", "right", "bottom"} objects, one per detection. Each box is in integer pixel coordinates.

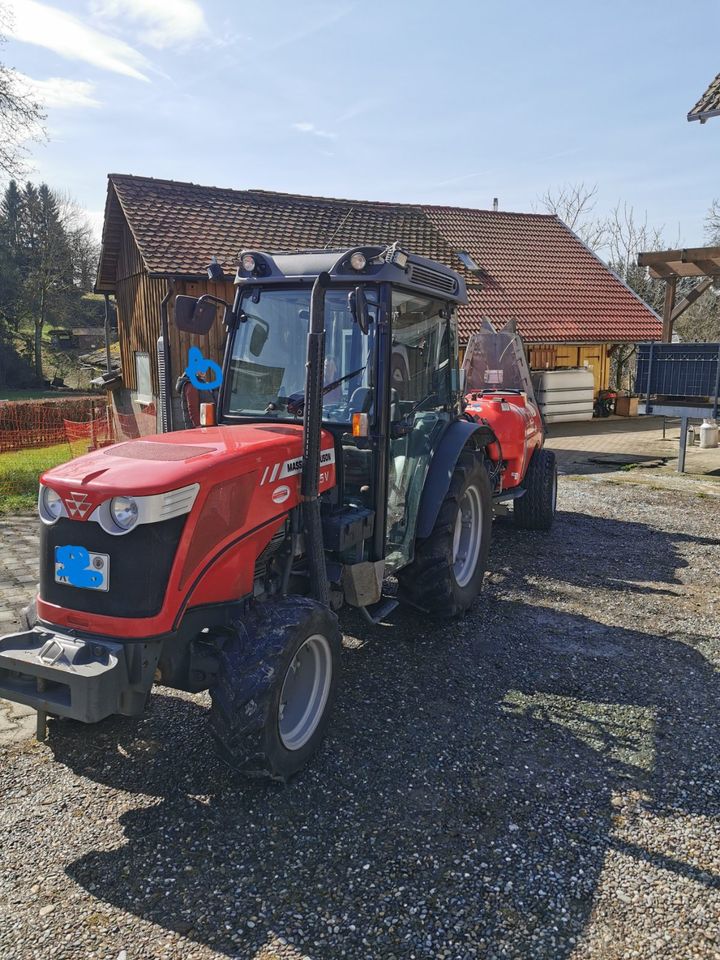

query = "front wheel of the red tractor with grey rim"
[{"left": 210, "top": 597, "right": 340, "bottom": 781}]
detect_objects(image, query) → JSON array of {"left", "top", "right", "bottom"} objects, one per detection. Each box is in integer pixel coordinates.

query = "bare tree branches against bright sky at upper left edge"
[{"left": 0, "top": 3, "right": 45, "bottom": 177}]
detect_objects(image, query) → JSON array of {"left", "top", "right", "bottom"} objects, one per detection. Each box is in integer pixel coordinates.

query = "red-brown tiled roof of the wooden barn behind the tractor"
[{"left": 98, "top": 174, "right": 661, "bottom": 342}]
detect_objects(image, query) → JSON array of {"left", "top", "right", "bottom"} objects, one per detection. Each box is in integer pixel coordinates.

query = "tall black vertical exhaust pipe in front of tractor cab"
[{"left": 300, "top": 272, "right": 330, "bottom": 607}]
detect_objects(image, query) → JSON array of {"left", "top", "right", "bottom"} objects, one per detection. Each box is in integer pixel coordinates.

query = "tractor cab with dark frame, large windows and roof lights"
[{"left": 175, "top": 245, "right": 466, "bottom": 572}]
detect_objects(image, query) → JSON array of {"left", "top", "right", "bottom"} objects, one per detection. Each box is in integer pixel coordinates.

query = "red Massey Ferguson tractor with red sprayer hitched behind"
[{"left": 0, "top": 245, "right": 554, "bottom": 779}]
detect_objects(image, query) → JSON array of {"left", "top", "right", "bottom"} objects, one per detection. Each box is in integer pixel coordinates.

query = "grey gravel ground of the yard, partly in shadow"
[{"left": 0, "top": 478, "right": 720, "bottom": 960}]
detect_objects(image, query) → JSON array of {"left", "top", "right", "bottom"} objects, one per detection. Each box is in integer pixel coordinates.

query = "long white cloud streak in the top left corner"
[{"left": 9, "top": 0, "right": 150, "bottom": 80}]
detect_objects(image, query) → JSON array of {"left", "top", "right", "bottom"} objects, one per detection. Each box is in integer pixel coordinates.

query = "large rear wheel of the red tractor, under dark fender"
[{"left": 398, "top": 449, "right": 492, "bottom": 619}]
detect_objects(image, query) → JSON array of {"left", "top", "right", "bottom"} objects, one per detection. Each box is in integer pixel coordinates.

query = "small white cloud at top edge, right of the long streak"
[{"left": 90, "top": 0, "right": 210, "bottom": 50}]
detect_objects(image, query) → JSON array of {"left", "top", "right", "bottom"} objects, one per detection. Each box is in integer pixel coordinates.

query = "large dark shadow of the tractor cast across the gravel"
[{"left": 50, "top": 506, "right": 720, "bottom": 960}]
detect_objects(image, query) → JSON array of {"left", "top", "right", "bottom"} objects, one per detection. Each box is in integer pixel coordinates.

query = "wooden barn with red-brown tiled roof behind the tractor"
[{"left": 96, "top": 174, "right": 661, "bottom": 432}]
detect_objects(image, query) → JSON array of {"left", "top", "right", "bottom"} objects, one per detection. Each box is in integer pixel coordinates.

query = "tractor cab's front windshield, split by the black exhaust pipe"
[{"left": 224, "top": 287, "right": 374, "bottom": 423}]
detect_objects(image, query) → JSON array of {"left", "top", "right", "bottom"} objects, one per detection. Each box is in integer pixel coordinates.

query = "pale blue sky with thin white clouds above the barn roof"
[{"left": 5, "top": 0, "right": 720, "bottom": 246}]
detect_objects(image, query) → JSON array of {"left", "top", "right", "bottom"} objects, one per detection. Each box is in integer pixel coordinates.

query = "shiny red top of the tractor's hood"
[{"left": 40, "top": 423, "right": 334, "bottom": 503}]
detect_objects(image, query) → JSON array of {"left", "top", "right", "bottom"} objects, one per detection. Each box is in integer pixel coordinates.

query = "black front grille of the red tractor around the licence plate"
[{"left": 40, "top": 516, "right": 185, "bottom": 618}]
